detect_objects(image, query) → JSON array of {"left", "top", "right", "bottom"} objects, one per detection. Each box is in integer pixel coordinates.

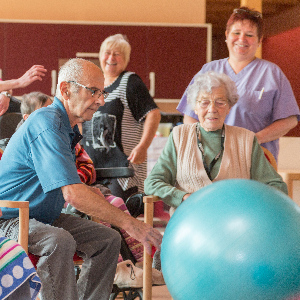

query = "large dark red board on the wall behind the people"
[{"left": 0, "top": 23, "right": 208, "bottom": 99}]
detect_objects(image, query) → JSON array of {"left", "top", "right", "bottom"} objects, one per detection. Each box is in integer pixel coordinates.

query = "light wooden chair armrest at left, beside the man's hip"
[{"left": 0, "top": 200, "right": 29, "bottom": 253}]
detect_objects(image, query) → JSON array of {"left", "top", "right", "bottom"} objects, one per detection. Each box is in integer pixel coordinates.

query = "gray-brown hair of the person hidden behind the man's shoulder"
[{"left": 21, "top": 92, "right": 52, "bottom": 115}]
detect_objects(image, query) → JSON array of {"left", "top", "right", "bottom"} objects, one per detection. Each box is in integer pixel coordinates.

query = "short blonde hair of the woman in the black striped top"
[{"left": 99, "top": 33, "right": 131, "bottom": 68}]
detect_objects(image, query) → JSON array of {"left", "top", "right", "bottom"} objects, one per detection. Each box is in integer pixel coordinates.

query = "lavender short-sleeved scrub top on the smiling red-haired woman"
[{"left": 177, "top": 58, "right": 300, "bottom": 160}]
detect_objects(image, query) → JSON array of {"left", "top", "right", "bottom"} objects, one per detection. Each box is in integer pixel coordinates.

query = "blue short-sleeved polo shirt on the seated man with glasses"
[{"left": 0, "top": 98, "right": 81, "bottom": 224}]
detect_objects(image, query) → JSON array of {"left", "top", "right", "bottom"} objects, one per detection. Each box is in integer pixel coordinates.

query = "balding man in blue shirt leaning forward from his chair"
[{"left": 0, "top": 59, "right": 162, "bottom": 300}]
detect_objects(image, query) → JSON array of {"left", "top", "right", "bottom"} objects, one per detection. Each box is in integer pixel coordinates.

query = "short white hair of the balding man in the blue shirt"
[{"left": 55, "top": 58, "right": 88, "bottom": 100}]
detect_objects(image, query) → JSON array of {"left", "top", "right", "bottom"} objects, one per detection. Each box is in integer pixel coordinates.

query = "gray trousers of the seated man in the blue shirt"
[{"left": 0, "top": 214, "right": 120, "bottom": 300}]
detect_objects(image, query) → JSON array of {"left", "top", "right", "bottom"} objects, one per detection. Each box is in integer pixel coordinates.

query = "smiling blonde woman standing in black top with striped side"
[{"left": 83, "top": 34, "right": 161, "bottom": 199}]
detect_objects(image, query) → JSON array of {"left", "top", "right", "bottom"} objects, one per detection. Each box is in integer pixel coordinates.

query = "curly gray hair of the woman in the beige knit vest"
[{"left": 187, "top": 71, "right": 239, "bottom": 109}]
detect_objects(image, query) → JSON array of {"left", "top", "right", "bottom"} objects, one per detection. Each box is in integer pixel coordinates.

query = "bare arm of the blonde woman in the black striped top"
[{"left": 128, "top": 108, "right": 161, "bottom": 164}]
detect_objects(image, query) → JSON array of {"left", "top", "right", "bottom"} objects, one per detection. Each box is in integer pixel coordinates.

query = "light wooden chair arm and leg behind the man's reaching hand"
[{"left": 143, "top": 195, "right": 160, "bottom": 300}]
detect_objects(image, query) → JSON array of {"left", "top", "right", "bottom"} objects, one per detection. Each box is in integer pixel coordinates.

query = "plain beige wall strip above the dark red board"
[{"left": 0, "top": 0, "right": 206, "bottom": 24}]
